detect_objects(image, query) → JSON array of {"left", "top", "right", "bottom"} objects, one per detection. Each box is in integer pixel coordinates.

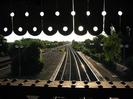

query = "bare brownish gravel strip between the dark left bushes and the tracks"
[{"left": 36, "top": 49, "right": 64, "bottom": 80}]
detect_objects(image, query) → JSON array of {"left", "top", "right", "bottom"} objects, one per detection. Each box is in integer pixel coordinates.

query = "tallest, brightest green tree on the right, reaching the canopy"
[{"left": 103, "top": 31, "right": 121, "bottom": 62}]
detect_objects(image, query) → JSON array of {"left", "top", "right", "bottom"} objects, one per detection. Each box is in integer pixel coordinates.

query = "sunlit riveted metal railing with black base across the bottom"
[{"left": 0, "top": 79, "right": 133, "bottom": 99}]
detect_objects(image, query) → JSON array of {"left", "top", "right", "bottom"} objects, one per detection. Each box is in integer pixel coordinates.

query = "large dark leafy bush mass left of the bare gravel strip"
[{"left": 9, "top": 39, "right": 43, "bottom": 76}]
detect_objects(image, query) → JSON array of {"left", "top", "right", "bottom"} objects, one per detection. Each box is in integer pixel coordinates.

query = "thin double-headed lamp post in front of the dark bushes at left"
[{"left": 15, "top": 45, "right": 24, "bottom": 77}]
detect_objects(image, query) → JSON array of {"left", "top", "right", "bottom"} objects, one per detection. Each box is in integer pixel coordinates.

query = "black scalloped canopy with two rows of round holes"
[{"left": 0, "top": 0, "right": 133, "bottom": 36}]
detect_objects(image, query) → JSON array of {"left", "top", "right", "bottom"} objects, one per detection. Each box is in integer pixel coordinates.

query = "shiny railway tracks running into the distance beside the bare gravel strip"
[{"left": 54, "top": 46, "right": 99, "bottom": 81}]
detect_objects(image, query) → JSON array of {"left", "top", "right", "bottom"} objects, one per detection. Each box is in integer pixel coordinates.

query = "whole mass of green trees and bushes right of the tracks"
[{"left": 80, "top": 31, "right": 121, "bottom": 70}]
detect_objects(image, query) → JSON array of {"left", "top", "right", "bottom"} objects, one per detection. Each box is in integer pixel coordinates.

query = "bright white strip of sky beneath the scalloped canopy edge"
[{"left": 5, "top": 32, "right": 95, "bottom": 42}]
